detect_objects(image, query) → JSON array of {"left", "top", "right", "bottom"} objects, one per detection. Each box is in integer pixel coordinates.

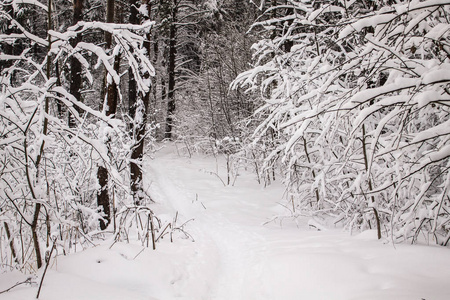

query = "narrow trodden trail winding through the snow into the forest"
[{"left": 149, "top": 148, "right": 274, "bottom": 300}]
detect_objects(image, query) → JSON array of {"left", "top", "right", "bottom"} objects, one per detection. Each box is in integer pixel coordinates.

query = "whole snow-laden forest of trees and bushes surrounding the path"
[{"left": 0, "top": 0, "right": 450, "bottom": 272}]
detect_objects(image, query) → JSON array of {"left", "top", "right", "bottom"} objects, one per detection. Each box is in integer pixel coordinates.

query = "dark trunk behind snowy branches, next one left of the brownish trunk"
[{"left": 68, "top": 0, "right": 83, "bottom": 128}]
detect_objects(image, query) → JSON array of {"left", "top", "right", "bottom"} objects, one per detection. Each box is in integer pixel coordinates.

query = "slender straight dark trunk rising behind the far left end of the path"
[{"left": 164, "top": 0, "right": 178, "bottom": 139}]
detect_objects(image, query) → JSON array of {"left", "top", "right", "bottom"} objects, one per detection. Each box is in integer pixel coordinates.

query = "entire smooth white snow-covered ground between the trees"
[{"left": 0, "top": 146, "right": 450, "bottom": 300}]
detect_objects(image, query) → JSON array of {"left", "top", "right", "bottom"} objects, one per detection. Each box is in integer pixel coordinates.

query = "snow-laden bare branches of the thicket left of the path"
[{"left": 0, "top": 0, "right": 161, "bottom": 272}]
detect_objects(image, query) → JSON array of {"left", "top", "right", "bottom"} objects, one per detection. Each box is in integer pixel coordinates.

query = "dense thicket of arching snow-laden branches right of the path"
[{"left": 234, "top": 0, "right": 450, "bottom": 245}]
